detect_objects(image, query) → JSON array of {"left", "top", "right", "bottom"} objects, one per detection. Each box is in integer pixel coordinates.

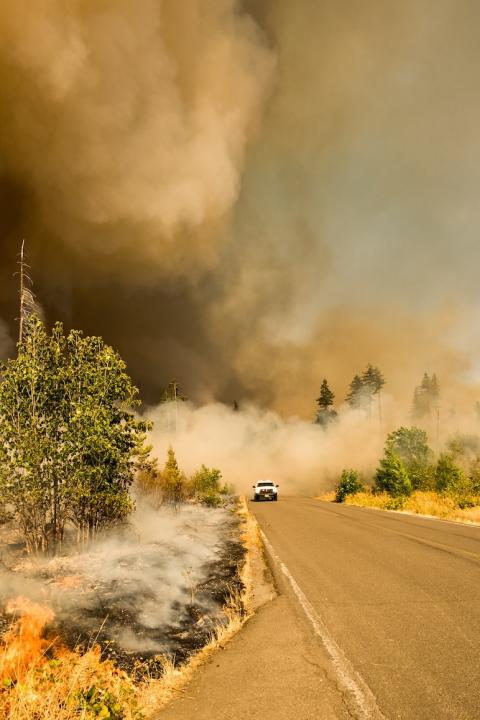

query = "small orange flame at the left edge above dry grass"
[{"left": 0, "top": 597, "right": 54, "bottom": 682}]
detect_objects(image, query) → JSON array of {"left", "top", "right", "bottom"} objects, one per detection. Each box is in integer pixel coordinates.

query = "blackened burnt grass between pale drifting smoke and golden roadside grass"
[{"left": 0, "top": 515, "right": 246, "bottom": 680}]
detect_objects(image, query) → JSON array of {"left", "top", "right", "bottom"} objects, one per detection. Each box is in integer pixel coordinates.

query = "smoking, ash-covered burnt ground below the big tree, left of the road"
[{"left": 0, "top": 505, "right": 245, "bottom": 675}]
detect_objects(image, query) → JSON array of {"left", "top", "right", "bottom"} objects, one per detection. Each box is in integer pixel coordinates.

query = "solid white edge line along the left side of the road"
[{"left": 260, "top": 530, "right": 386, "bottom": 720}]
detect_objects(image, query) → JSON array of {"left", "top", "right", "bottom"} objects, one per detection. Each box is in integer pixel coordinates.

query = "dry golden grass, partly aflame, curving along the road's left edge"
[{"left": 0, "top": 499, "right": 260, "bottom": 720}]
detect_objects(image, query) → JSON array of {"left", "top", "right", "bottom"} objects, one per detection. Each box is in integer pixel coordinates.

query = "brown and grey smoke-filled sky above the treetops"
[{"left": 0, "top": 0, "right": 480, "bottom": 416}]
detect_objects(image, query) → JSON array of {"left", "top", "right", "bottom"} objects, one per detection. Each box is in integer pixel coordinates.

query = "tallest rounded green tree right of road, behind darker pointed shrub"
[{"left": 386, "top": 427, "right": 433, "bottom": 490}]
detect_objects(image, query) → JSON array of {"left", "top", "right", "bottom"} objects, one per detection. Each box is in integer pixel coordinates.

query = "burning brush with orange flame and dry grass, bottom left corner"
[{"left": 0, "top": 598, "right": 152, "bottom": 720}]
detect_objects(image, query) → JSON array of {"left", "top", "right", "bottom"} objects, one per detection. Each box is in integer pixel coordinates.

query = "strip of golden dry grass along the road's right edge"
[{"left": 340, "top": 490, "right": 480, "bottom": 523}]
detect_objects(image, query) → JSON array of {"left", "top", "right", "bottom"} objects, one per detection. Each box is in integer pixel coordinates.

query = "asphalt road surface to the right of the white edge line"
[{"left": 250, "top": 498, "right": 480, "bottom": 720}]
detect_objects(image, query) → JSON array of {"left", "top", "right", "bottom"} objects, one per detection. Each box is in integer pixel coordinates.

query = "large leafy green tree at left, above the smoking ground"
[{"left": 0, "top": 316, "right": 147, "bottom": 551}]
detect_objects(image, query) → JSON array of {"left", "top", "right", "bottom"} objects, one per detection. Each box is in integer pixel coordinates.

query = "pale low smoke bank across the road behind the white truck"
[{"left": 149, "top": 403, "right": 388, "bottom": 495}]
